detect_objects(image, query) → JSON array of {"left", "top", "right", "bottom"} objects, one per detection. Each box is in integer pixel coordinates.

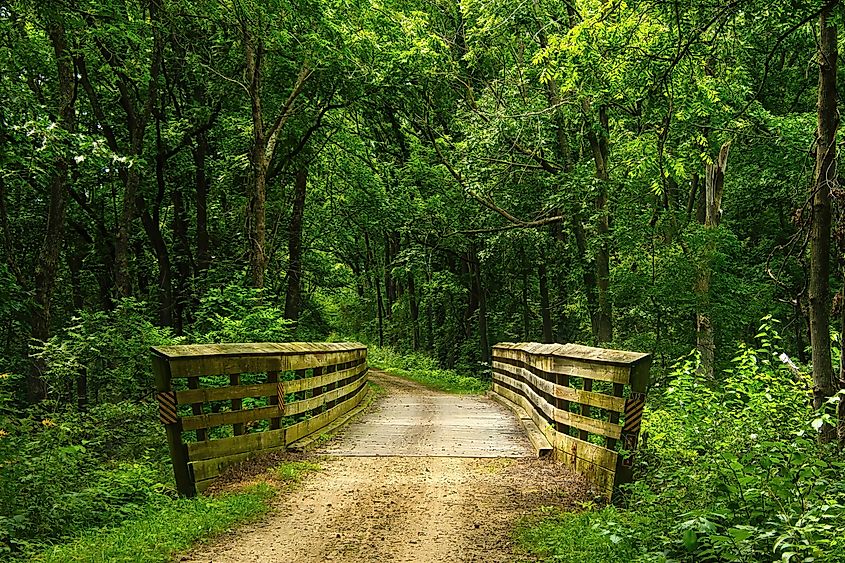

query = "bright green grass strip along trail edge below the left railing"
[{"left": 33, "top": 484, "right": 275, "bottom": 563}]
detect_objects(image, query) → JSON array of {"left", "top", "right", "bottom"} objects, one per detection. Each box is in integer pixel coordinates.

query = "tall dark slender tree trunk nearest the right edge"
[{"left": 809, "top": 10, "right": 839, "bottom": 442}]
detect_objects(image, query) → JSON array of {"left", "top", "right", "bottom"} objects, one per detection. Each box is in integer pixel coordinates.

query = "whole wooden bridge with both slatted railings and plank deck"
[{"left": 153, "top": 342, "right": 651, "bottom": 498}]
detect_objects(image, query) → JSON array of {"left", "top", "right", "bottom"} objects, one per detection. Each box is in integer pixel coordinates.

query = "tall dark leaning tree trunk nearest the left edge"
[{"left": 27, "top": 17, "right": 76, "bottom": 403}]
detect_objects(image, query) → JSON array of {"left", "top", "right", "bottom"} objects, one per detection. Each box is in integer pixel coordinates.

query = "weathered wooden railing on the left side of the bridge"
[{"left": 152, "top": 342, "right": 368, "bottom": 496}]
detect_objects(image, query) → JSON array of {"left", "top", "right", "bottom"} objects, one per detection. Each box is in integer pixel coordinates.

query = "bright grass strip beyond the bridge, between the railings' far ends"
[{"left": 367, "top": 346, "right": 490, "bottom": 395}]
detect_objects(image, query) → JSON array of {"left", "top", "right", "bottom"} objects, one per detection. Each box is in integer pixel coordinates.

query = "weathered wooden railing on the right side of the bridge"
[{"left": 493, "top": 343, "right": 651, "bottom": 499}]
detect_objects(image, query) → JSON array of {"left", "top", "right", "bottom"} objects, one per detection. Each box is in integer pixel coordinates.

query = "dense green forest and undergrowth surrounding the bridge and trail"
[{"left": 0, "top": 0, "right": 845, "bottom": 563}]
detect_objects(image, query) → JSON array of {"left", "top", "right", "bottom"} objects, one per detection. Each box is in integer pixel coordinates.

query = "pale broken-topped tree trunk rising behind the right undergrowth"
[{"left": 695, "top": 142, "right": 731, "bottom": 381}]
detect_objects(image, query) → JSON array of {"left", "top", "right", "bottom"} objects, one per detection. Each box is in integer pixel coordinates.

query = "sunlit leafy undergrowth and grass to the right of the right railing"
[{"left": 519, "top": 320, "right": 845, "bottom": 563}]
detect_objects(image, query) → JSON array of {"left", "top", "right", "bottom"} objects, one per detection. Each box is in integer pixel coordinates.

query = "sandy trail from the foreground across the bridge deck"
[{"left": 181, "top": 374, "right": 581, "bottom": 563}]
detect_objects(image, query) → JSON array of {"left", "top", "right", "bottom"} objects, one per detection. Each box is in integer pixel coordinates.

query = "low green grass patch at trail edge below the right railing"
[{"left": 517, "top": 507, "right": 639, "bottom": 563}]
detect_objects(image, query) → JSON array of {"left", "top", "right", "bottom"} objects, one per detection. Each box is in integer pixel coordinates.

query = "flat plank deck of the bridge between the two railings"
[{"left": 320, "top": 370, "right": 534, "bottom": 458}]
